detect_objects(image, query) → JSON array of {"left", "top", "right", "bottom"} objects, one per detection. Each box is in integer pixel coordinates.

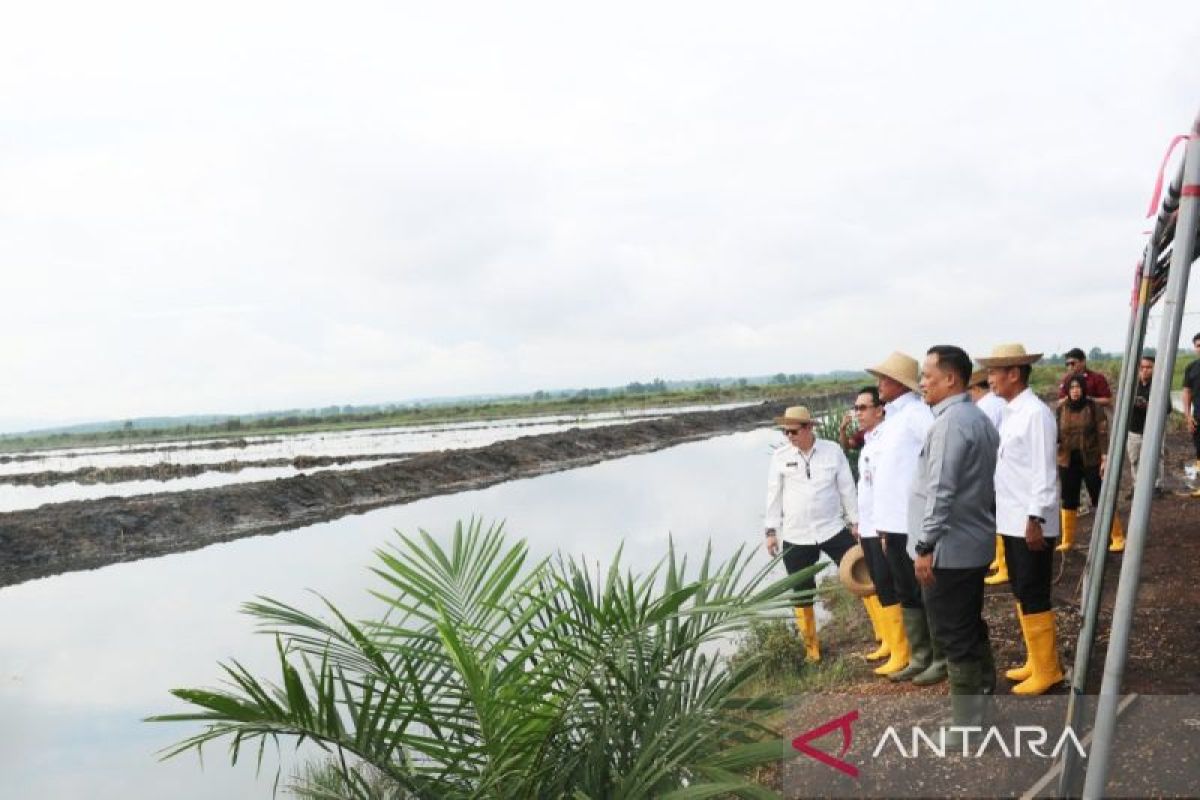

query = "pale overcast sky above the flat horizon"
[{"left": 0, "top": 0, "right": 1200, "bottom": 429}]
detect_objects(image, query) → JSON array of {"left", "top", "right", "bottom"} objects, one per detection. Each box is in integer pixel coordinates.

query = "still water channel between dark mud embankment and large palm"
[{"left": 0, "top": 429, "right": 825, "bottom": 800}]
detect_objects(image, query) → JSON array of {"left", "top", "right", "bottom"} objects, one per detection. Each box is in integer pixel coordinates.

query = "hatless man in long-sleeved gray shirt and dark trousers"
[{"left": 908, "top": 344, "right": 1000, "bottom": 748}]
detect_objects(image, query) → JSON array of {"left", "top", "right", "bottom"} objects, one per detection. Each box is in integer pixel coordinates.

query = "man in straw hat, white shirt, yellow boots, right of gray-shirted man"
[{"left": 979, "top": 344, "right": 1062, "bottom": 694}]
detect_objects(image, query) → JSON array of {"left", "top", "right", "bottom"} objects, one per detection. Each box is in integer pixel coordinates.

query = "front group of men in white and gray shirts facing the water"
[{"left": 766, "top": 344, "right": 1080, "bottom": 726}]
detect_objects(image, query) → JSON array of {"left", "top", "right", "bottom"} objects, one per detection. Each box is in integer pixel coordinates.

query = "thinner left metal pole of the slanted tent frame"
[{"left": 1058, "top": 255, "right": 1158, "bottom": 798}]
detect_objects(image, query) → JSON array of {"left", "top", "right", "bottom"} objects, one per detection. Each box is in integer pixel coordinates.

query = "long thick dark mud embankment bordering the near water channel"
[{"left": 0, "top": 403, "right": 806, "bottom": 587}]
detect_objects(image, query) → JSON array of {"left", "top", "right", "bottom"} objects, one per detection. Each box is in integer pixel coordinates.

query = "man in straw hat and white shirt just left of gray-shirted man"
[{"left": 866, "top": 353, "right": 946, "bottom": 685}]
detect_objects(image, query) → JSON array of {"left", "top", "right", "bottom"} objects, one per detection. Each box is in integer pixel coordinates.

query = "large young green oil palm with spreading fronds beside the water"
[{"left": 151, "top": 521, "right": 803, "bottom": 800}]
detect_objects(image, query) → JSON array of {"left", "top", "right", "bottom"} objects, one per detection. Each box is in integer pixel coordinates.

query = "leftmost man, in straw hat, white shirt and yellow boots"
[{"left": 766, "top": 405, "right": 858, "bottom": 662}]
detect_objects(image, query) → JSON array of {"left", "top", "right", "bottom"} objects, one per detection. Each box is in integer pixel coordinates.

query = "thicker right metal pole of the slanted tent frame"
[{"left": 1082, "top": 137, "right": 1200, "bottom": 800}]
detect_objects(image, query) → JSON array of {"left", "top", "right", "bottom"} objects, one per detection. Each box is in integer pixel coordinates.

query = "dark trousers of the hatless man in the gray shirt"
[{"left": 921, "top": 566, "right": 988, "bottom": 663}]
